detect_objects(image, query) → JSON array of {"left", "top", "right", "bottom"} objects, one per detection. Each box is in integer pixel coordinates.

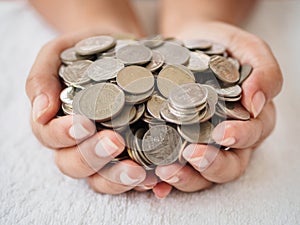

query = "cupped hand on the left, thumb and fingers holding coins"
[{"left": 26, "top": 30, "right": 157, "bottom": 194}]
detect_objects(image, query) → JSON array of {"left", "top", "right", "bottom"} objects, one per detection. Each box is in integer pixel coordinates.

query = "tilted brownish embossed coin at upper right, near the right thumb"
[{"left": 209, "top": 56, "right": 240, "bottom": 84}]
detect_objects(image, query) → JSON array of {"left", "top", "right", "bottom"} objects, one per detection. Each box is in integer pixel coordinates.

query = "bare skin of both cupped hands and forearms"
[{"left": 26, "top": 0, "right": 282, "bottom": 198}]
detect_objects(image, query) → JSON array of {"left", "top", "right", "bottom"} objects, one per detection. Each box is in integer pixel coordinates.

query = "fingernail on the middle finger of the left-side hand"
[{"left": 95, "top": 137, "right": 119, "bottom": 158}]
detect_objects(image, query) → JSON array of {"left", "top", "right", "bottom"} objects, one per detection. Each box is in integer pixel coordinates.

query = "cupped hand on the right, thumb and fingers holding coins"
[{"left": 156, "top": 21, "right": 283, "bottom": 195}]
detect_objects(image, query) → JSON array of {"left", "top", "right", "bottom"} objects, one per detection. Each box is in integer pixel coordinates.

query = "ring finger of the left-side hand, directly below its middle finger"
[{"left": 88, "top": 160, "right": 146, "bottom": 194}]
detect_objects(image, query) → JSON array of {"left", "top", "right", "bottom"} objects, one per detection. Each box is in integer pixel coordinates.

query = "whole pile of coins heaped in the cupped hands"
[{"left": 58, "top": 36, "right": 252, "bottom": 170}]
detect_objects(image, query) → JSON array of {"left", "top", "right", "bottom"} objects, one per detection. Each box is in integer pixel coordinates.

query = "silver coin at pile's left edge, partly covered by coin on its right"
[{"left": 63, "top": 60, "right": 93, "bottom": 85}]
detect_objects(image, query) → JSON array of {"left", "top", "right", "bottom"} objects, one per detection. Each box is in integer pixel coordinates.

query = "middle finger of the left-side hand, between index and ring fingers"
[{"left": 55, "top": 130, "right": 125, "bottom": 178}]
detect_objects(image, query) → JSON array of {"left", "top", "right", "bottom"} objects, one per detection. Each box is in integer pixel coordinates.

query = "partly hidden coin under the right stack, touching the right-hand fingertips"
[{"left": 177, "top": 121, "right": 214, "bottom": 144}]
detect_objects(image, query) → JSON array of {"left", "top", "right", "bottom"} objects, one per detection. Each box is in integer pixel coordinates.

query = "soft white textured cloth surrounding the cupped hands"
[{"left": 0, "top": 1, "right": 300, "bottom": 225}]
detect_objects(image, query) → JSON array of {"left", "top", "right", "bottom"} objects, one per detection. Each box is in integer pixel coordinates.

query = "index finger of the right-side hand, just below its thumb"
[{"left": 212, "top": 102, "right": 275, "bottom": 148}]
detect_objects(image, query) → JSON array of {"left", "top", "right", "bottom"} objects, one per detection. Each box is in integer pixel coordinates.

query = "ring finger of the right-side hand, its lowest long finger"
[{"left": 155, "top": 163, "right": 212, "bottom": 192}]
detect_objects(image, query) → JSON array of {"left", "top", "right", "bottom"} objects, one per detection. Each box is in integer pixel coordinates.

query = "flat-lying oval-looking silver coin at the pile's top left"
[{"left": 75, "top": 36, "right": 115, "bottom": 55}]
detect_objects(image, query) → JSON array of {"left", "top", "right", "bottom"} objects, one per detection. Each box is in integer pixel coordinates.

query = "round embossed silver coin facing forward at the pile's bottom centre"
[{"left": 142, "top": 125, "right": 182, "bottom": 166}]
